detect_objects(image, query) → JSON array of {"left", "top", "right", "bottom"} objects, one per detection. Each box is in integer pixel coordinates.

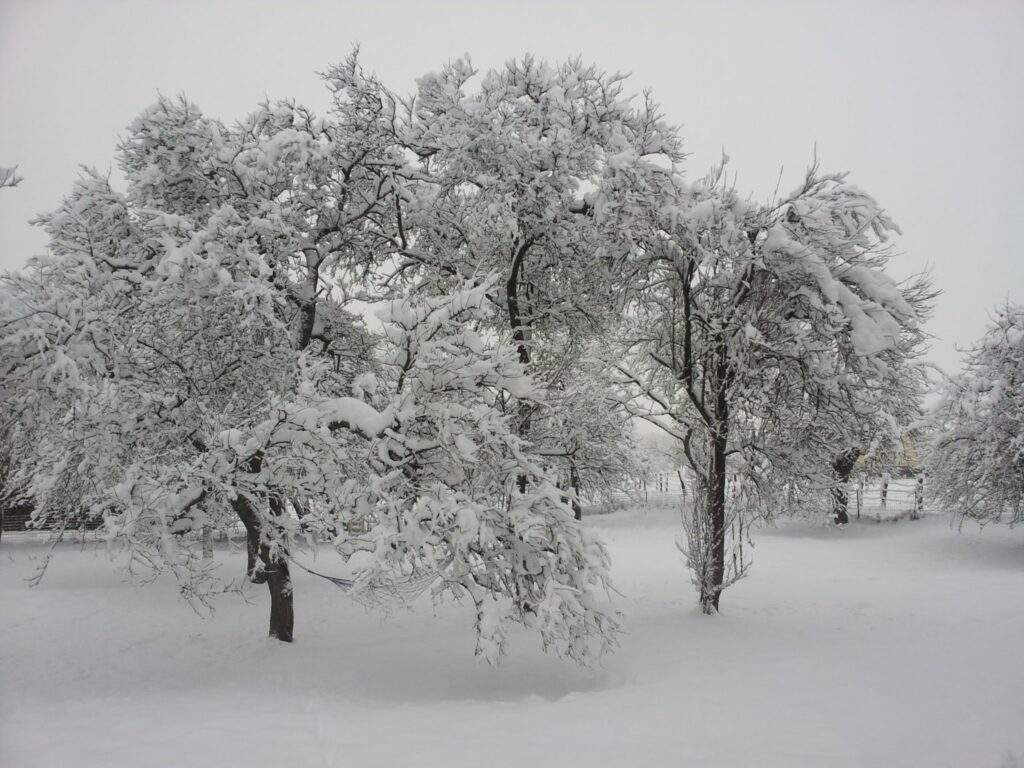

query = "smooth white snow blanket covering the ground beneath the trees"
[{"left": 0, "top": 510, "right": 1024, "bottom": 768}]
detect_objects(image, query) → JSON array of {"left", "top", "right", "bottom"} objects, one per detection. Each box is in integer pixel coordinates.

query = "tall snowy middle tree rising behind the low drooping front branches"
[{"left": 327, "top": 56, "right": 682, "bottom": 493}]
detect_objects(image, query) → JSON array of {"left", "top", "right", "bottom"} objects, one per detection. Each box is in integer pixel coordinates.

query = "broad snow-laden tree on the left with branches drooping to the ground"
[{"left": 0, "top": 67, "right": 616, "bottom": 662}]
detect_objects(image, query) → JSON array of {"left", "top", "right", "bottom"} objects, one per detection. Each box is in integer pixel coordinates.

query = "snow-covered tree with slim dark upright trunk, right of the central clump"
[{"left": 618, "top": 160, "right": 937, "bottom": 612}]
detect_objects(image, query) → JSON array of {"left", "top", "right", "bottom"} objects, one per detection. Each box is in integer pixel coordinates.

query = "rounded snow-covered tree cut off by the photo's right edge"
[{"left": 928, "top": 302, "right": 1024, "bottom": 525}]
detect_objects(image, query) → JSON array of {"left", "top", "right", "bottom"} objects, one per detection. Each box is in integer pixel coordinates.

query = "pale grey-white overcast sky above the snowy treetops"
[{"left": 0, "top": 0, "right": 1024, "bottom": 368}]
